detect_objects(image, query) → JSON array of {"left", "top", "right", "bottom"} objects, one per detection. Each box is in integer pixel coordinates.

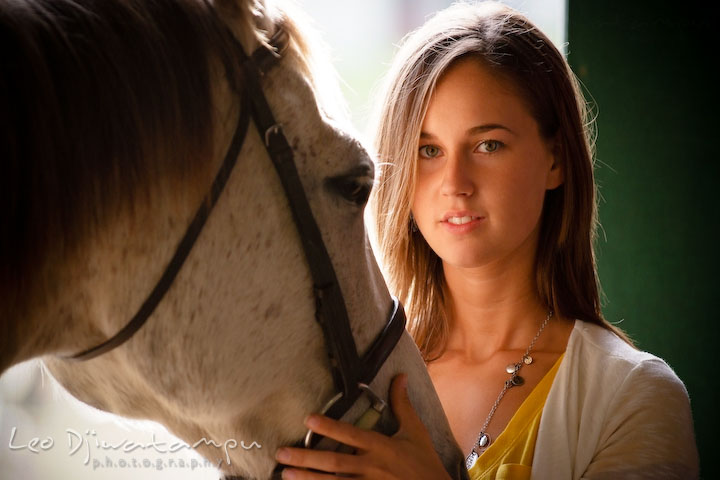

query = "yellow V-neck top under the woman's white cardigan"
[{"left": 468, "top": 354, "right": 565, "bottom": 480}]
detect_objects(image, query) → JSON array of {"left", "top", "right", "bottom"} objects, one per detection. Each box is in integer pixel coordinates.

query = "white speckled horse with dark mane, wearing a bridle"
[{"left": 0, "top": 0, "right": 467, "bottom": 479}]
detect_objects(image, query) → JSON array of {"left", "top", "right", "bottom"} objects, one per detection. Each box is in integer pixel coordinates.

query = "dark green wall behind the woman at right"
[{"left": 568, "top": 0, "right": 720, "bottom": 479}]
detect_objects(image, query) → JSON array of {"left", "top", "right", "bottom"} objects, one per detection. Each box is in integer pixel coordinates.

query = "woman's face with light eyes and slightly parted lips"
[{"left": 412, "top": 59, "right": 563, "bottom": 268}]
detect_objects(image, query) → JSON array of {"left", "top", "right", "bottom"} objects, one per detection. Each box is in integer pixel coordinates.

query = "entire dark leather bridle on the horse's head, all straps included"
[{"left": 66, "top": 15, "right": 405, "bottom": 478}]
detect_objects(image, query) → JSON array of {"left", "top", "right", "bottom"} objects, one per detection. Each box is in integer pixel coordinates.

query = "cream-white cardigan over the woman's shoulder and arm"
[{"left": 532, "top": 320, "right": 699, "bottom": 480}]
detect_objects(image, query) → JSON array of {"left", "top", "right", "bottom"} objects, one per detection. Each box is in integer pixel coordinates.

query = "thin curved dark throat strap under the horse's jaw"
[{"left": 65, "top": 86, "right": 250, "bottom": 361}]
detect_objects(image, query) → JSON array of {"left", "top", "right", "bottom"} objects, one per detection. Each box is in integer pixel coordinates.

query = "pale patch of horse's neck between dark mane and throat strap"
[{"left": 8, "top": 182, "right": 207, "bottom": 366}]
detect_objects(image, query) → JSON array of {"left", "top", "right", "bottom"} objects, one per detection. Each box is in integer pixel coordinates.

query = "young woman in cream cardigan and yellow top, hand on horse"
[{"left": 278, "top": 3, "right": 698, "bottom": 479}]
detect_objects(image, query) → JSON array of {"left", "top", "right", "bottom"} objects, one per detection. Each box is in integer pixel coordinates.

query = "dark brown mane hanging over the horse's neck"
[{"left": 0, "top": 0, "right": 249, "bottom": 359}]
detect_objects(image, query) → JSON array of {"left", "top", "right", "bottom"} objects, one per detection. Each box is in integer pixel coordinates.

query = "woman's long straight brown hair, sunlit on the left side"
[{"left": 371, "top": 3, "right": 629, "bottom": 361}]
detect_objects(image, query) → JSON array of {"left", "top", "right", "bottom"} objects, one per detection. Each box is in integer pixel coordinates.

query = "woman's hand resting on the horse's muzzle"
[{"left": 275, "top": 374, "right": 450, "bottom": 480}]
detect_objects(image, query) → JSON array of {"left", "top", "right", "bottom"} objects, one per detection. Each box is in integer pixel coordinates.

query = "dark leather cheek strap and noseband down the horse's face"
[{"left": 236, "top": 28, "right": 405, "bottom": 446}]
